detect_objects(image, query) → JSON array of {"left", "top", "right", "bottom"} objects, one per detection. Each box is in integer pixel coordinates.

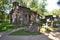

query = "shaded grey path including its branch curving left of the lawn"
[{"left": 0, "top": 28, "right": 50, "bottom": 40}]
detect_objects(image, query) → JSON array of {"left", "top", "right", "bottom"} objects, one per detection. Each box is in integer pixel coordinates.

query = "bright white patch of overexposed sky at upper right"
[{"left": 46, "top": 0, "right": 60, "bottom": 11}]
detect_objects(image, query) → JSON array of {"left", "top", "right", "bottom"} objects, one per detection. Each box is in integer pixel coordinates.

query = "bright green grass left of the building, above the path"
[{"left": 0, "top": 21, "right": 14, "bottom": 32}]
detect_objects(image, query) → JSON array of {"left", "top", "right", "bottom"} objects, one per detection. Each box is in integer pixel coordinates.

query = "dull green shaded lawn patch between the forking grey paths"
[{"left": 10, "top": 30, "right": 41, "bottom": 35}]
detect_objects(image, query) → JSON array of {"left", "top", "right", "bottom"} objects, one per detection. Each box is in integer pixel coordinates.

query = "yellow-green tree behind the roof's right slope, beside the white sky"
[{"left": 30, "top": 0, "right": 47, "bottom": 15}]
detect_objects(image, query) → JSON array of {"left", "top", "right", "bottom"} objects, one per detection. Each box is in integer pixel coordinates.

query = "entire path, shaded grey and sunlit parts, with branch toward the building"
[{"left": 0, "top": 27, "right": 60, "bottom": 40}]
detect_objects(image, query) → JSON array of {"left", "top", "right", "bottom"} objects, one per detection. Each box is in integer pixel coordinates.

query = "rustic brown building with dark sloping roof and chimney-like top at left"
[{"left": 10, "top": 2, "right": 41, "bottom": 25}]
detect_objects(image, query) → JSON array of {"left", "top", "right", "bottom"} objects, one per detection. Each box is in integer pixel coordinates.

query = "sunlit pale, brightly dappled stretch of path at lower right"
[{"left": 45, "top": 25, "right": 60, "bottom": 40}]
